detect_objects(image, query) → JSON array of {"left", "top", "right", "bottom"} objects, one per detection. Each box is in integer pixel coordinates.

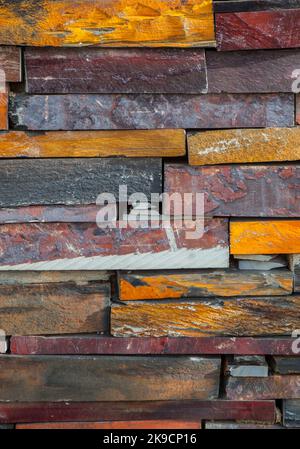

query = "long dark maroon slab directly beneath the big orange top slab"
[{"left": 25, "top": 47, "right": 207, "bottom": 94}]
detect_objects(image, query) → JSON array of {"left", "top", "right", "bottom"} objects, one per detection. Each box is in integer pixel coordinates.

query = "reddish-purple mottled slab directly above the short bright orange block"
[{"left": 164, "top": 164, "right": 300, "bottom": 217}]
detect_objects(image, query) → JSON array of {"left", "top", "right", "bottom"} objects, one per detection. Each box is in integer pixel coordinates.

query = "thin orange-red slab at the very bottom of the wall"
[{"left": 16, "top": 420, "right": 201, "bottom": 430}]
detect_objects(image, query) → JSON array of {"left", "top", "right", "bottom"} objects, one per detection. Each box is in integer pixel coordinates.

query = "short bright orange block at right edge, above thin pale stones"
[{"left": 230, "top": 220, "right": 300, "bottom": 254}]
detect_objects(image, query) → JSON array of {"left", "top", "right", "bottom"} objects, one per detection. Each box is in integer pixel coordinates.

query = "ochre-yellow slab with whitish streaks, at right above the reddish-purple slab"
[{"left": 188, "top": 128, "right": 300, "bottom": 165}]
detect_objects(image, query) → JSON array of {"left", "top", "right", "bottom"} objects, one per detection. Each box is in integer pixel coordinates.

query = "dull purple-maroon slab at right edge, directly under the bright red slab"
[{"left": 206, "top": 50, "right": 300, "bottom": 93}]
